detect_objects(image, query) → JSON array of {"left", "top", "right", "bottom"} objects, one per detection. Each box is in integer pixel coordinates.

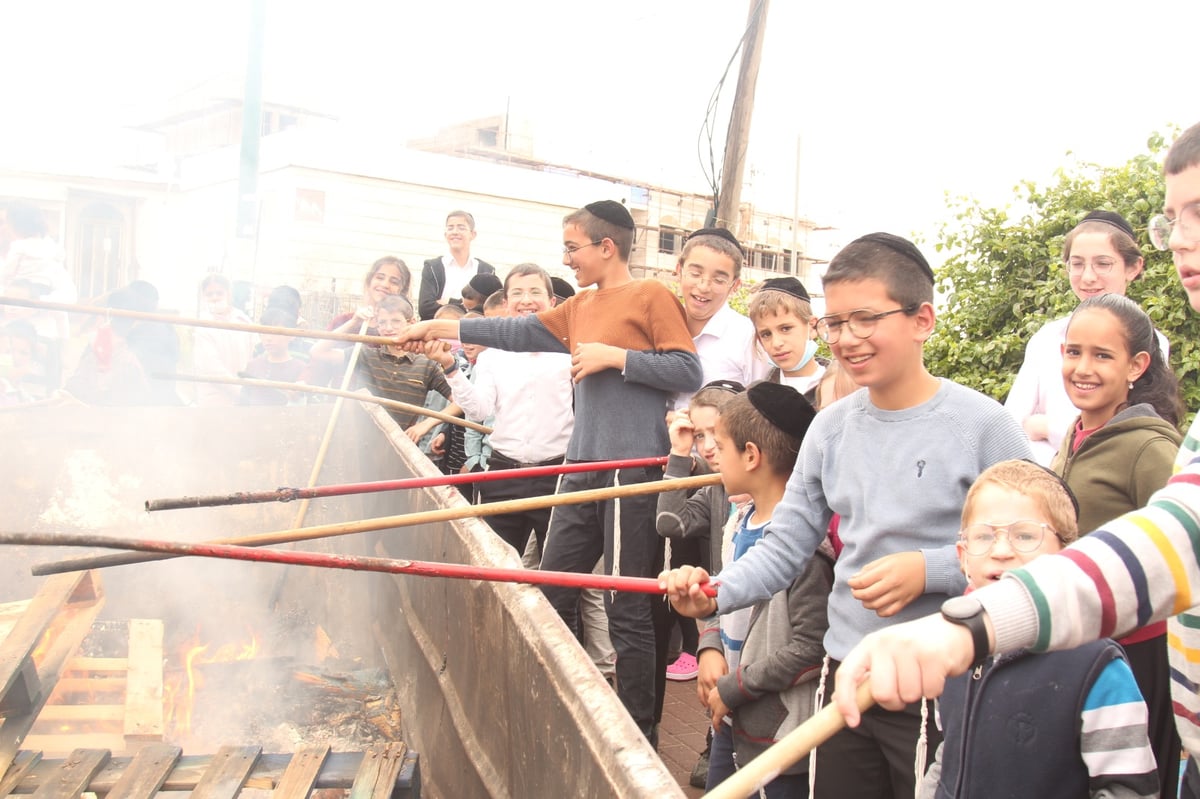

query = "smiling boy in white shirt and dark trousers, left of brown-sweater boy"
[{"left": 426, "top": 263, "right": 575, "bottom": 555}]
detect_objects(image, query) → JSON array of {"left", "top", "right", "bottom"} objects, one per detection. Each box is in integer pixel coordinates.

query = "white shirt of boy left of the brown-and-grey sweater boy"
[{"left": 446, "top": 349, "right": 575, "bottom": 463}]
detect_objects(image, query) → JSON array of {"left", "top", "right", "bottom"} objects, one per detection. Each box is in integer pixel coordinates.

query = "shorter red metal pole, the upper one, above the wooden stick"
[{"left": 146, "top": 457, "right": 667, "bottom": 511}]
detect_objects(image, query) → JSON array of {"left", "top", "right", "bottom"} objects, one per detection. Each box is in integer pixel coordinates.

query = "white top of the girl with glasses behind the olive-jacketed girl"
[{"left": 1004, "top": 314, "right": 1171, "bottom": 467}]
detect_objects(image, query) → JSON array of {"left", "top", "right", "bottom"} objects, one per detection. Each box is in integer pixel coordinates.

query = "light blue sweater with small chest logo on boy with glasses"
[{"left": 716, "top": 379, "right": 1031, "bottom": 660}]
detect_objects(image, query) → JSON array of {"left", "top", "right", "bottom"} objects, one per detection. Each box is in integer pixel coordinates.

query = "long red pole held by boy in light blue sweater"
[{"left": 0, "top": 533, "right": 716, "bottom": 596}]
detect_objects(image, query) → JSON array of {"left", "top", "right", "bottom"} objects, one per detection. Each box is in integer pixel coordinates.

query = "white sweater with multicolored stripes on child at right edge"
[{"left": 974, "top": 417, "right": 1200, "bottom": 755}]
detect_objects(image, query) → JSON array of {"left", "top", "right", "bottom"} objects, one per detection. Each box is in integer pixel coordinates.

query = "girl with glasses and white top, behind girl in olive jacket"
[{"left": 1004, "top": 211, "right": 1170, "bottom": 467}]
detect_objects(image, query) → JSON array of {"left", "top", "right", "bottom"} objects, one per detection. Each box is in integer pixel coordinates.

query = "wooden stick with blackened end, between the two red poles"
[{"left": 31, "top": 474, "right": 721, "bottom": 576}]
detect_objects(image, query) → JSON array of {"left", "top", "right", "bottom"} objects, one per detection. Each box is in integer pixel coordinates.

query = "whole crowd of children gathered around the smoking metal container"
[{"left": 11, "top": 126, "right": 1200, "bottom": 799}]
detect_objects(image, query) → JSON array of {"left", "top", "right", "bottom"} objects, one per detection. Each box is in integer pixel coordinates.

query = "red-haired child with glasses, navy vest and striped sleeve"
[{"left": 918, "top": 458, "right": 1156, "bottom": 799}]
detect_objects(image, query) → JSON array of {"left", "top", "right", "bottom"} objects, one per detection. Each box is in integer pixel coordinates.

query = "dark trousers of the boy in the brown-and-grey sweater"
[{"left": 541, "top": 467, "right": 662, "bottom": 738}]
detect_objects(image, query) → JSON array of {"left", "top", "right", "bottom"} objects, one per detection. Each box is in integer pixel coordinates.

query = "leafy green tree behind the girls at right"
[{"left": 925, "top": 133, "right": 1200, "bottom": 419}]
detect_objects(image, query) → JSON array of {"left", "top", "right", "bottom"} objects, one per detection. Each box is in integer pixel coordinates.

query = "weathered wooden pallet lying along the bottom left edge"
[{"left": 0, "top": 743, "right": 421, "bottom": 799}]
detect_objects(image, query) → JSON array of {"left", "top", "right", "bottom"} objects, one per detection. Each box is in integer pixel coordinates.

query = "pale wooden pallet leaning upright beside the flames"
[{"left": 22, "top": 619, "right": 164, "bottom": 755}]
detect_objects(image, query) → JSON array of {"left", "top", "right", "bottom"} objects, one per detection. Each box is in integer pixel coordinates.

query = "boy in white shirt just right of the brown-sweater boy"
[{"left": 674, "top": 228, "right": 767, "bottom": 410}]
